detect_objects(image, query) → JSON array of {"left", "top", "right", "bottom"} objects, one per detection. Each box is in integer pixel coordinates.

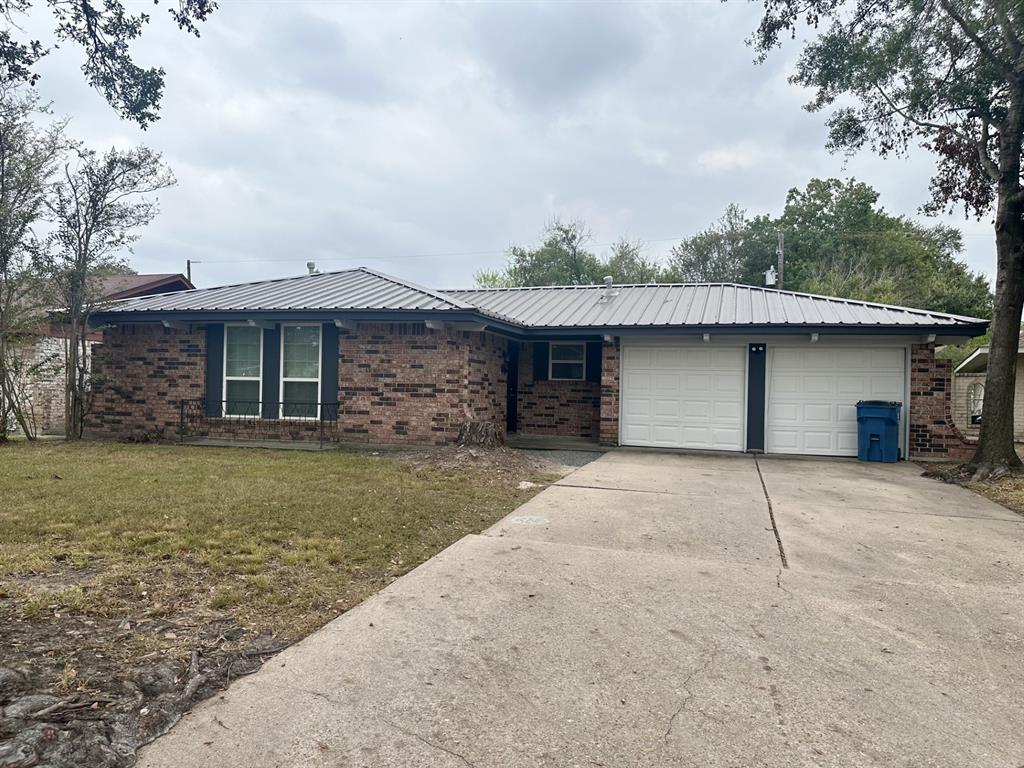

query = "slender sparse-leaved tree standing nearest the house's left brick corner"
[{"left": 49, "top": 146, "right": 174, "bottom": 439}]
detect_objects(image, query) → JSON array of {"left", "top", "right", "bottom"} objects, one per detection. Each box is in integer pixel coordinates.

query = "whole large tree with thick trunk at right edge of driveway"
[{"left": 752, "top": 0, "right": 1024, "bottom": 476}]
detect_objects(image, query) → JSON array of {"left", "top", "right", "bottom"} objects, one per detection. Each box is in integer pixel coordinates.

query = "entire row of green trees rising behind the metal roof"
[{"left": 475, "top": 178, "right": 992, "bottom": 317}]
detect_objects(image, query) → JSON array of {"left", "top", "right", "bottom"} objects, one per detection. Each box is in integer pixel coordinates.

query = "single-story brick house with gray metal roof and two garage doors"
[{"left": 89, "top": 268, "right": 987, "bottom": 458}]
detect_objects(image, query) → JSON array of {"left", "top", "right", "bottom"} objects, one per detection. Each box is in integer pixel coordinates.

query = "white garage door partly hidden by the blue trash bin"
[{"left": 765, "top": 345, "right": 906, "bottom": 456}]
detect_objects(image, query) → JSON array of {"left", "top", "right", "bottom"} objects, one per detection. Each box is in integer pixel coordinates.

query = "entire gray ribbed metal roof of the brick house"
[{"left": 97, "top": 267, "right": 987, "bottom": 330}]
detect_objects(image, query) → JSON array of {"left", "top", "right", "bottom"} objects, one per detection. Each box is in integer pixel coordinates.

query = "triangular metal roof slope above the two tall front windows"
[{"left": 100, "top": 267, "right": 474, "bottom": 315}]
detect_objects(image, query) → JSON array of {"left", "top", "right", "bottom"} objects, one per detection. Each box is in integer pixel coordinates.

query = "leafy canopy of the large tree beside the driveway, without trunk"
[{"left": 752, "top": 0, "right": 1024, "bottom": 216}]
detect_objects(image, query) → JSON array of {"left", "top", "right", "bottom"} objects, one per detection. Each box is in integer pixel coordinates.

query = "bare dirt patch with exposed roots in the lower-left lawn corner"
[{"left": 0, "top": 604, "right": 288, "bottom": 768}]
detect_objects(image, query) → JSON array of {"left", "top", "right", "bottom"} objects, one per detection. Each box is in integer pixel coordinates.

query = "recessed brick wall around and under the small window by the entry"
[{"left": 516, "top": 342, "right": 601, "bottom": 440}]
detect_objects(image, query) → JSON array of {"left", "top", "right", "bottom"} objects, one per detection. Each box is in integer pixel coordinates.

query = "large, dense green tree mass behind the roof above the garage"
[{"left": 669, "top": 179, "right": 991, "bottom": 317}]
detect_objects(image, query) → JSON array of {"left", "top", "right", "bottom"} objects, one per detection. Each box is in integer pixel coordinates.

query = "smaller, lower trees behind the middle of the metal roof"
[{"left": 473, "top": 219, "right": 662, "bottom": 288}]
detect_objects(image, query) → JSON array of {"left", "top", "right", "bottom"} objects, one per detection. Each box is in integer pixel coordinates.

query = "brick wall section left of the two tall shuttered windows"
[{"left": 86, "top": 326, "right": 206, "bottom": 439}]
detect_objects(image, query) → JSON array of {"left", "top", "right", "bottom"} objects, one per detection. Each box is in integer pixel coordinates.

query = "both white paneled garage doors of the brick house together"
[{"left": 621, "top": 341, "right": 906, "bottom": 456}]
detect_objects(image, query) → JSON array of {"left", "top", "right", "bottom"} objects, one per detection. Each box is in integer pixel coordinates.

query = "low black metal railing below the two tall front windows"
[{"left": 178, "top": 398, "right": 338, "bottom": 447}]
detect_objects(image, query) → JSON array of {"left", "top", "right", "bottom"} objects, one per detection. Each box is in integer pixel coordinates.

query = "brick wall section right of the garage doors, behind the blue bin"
[{"left": 908, "top": 343, "right": 975, "bottom": 461}]
